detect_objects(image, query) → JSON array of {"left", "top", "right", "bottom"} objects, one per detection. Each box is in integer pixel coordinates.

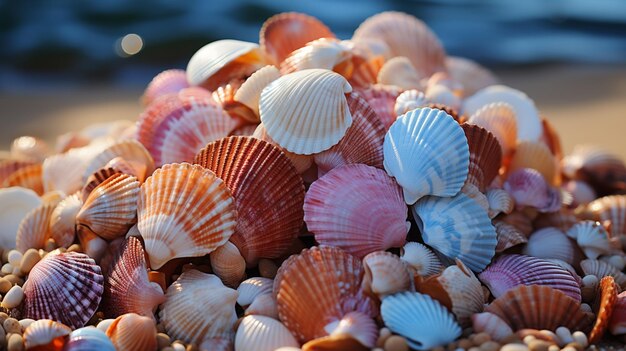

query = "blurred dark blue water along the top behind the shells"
[{"left": 0, "top": 0, "right": 626, "bottom": 90}]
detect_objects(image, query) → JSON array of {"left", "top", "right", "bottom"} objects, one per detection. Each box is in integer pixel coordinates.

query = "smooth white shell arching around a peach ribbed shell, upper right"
[{"left": 463, "top": 85, "right": 543, "bottom": 142}]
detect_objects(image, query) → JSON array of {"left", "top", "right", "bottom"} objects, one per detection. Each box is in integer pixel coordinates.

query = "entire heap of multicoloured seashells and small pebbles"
[{"left": 0, "top": 12, "right": 626, "bottom": 351}]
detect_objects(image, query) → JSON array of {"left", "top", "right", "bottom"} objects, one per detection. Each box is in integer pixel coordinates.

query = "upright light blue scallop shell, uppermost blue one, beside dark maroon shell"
[{"left": 383, "top": 108, "right": 469, "bottom": 204}]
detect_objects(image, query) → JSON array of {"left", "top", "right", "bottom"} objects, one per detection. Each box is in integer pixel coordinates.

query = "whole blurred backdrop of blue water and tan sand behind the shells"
[{"left": 0, "top": 0, "right": 626, "bottom": 158}]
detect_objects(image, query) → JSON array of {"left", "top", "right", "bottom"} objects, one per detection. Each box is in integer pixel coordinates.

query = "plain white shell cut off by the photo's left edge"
[{"left": 0, "top": 187, "right": 41, "bottom": 250}]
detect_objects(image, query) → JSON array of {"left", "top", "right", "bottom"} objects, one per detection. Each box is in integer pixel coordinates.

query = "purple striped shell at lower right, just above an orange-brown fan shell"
[{"left": 478, "top": 255, "right": 581, "bottom": 301}]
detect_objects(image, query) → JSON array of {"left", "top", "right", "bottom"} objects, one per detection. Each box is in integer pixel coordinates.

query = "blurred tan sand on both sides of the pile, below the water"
[{"left": 0, "top": 65, "right": 626, "bottom": 160}]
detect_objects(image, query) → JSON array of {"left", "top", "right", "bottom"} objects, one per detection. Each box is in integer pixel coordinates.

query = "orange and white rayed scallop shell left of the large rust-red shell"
[{"left": 137, "top": 163, "right": 237, "bottom": 269}]
